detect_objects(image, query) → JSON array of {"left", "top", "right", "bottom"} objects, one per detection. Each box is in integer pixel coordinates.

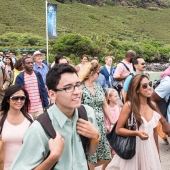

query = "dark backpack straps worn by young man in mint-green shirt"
[{"left": 36, "top": 105, "right": 89, "bottom": 170}]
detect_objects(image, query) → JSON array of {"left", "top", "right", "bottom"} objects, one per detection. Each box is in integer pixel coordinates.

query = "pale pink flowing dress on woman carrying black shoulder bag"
[{"left": 107, "top": 111, "right": 161, "bottom": 170}]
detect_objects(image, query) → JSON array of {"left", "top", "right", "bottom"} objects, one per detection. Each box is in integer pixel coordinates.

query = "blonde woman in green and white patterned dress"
[{"left": 79, "top": 63, "right": 113, "bottom": 170}]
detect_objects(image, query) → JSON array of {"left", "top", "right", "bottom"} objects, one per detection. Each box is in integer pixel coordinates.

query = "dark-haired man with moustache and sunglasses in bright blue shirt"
[{"left": 123, "top": 56, "right": 146, "bottom": 101}]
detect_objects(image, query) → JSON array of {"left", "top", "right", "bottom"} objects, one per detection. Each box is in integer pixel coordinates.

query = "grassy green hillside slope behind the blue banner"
[{"left": 0, "top": 0, "right": 170, "bottom": 44}]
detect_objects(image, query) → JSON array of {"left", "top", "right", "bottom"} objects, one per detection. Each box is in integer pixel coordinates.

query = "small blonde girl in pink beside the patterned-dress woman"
[{"left": 105, "top": 88, "right": 121, "bottom": 132}]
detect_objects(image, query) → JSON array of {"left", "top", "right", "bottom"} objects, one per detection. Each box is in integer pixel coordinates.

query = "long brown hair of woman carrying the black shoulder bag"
[{"left": 126, "top": 74, "right": 156, "bottom": 127}]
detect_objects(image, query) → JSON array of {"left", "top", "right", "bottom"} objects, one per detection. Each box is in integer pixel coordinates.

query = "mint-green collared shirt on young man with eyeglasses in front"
[{"left": 10, "top": 104, "right": 98, "bottom": 170}]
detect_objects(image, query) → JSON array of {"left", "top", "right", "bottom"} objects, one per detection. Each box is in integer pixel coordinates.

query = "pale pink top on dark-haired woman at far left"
[{"left": 2, "top": 118, "right": 30, "bottom": 170}]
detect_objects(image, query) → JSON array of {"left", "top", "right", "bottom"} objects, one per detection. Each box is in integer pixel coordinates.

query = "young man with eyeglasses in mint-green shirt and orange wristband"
[{"left": 11, "top": 64, "right": 100, "bottom": 170}]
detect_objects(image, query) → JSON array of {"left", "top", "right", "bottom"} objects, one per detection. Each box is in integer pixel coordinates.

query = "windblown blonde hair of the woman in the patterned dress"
[{"left": 78, "top": 62, "right": 100, "bottom": 82}]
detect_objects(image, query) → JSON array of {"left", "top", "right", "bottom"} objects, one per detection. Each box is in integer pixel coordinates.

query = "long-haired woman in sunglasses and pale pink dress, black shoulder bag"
[{"left": 108, "top": 75, "right": 161, "bottom": 170}]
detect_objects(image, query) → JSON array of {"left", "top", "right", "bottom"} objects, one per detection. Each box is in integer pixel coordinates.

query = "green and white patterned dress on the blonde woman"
[{"left": 82, "top": 82, "right": 111, "bottom": 163}]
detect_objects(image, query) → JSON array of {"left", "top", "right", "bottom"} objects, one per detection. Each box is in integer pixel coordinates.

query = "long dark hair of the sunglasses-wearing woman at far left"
[{"left": 0, "top": 84, "right": 33, "bottom": 127}]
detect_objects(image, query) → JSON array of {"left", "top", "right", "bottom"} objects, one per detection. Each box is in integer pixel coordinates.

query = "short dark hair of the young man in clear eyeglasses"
[{"left": 46, "top": 63, "right": 77, "bottom": 90}]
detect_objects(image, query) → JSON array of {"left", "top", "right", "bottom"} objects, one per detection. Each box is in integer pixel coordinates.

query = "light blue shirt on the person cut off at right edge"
[{"left": 155, "top": 76, "right": 170, "bottom": 123}]
